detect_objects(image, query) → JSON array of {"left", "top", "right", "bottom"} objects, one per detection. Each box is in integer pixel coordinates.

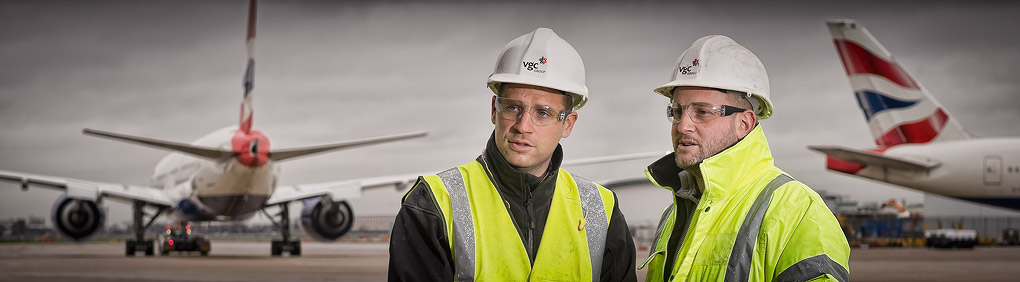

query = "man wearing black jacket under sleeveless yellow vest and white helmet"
[{"left": 389, "top": 28, "right": 636, "bottom": 281}]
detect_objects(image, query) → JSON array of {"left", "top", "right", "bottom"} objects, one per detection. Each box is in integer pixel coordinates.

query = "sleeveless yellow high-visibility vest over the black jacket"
[{"left": 424, "top": 161, "right": 615, "bottom": 281}]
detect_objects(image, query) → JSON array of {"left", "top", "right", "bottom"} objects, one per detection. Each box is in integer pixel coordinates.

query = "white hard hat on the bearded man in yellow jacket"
[{"left": 655, "top": 35, "right": 772, "bottom": 120}]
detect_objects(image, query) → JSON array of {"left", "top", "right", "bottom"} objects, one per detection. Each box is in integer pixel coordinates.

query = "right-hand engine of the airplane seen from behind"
[{"left": 301, "top": 198, "right": 354, "bottom": 241}]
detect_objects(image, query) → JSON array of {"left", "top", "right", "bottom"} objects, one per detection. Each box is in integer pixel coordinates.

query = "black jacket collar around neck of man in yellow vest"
[{"left": 478, "top": 132, "right": 563, "bottom": 193}]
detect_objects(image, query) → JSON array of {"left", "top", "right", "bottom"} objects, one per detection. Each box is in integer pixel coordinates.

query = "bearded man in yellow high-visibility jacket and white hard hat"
[{"left": 641, "top": 36, "right": 850, "bottom": 282}]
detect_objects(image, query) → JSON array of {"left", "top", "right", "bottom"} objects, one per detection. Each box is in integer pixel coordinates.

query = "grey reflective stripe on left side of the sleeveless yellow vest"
[{"left": 437, "top": 168, "right": 474, "bottom": 281}]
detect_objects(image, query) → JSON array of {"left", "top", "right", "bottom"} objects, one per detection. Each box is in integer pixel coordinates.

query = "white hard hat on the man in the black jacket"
[{"left": 488, "top": 28, "right": 588, "bottom": 110}]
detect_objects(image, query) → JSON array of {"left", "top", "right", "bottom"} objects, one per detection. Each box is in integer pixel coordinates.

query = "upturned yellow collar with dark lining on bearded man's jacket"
[{"left": 645, "top": 125, "right": 773, "bottom": 202}]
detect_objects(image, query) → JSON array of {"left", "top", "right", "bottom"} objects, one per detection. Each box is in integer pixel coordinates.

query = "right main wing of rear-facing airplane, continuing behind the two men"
[{"left": 265, "top": 152, "right": 663, "bottom": 205}]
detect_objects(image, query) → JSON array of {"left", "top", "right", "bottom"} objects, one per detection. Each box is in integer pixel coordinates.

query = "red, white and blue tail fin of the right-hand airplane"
[{"left": 826, "top": 19, "right": 970, "bottom": 147}]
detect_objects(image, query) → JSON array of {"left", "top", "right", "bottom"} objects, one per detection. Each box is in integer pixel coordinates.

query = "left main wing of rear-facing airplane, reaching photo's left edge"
[{"left": 0, "top": 171, "right": 174, "bottom": 207}]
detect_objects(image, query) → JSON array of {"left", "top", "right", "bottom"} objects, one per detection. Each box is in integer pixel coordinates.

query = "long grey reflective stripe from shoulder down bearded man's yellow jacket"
[{"left": 723, "top": 175, "right": 794, "bottom": 281}]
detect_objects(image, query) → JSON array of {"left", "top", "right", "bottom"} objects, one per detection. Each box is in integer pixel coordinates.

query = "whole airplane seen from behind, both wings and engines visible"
[{"left": 0, "top": 0, "right": 660, "bottom": 256}]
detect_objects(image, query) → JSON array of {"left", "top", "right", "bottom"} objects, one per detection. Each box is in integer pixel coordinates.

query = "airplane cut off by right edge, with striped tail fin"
[{"left": 808, "top": 19, "right": 1020, "bottom": 210}]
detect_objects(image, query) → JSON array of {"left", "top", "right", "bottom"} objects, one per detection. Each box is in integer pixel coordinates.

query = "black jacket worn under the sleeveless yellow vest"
[{"left": 389, "top": 132, "right": 638, "bottom": 281}]
